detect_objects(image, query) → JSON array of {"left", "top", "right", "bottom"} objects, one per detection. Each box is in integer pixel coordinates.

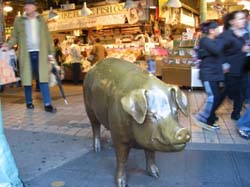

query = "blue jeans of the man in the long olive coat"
[{"left": 24, "top": 51, "right": 51, "bottom": 105}]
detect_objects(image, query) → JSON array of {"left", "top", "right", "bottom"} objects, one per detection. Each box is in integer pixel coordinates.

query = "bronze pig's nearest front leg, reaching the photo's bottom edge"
[{"left": 115, "top": 144, "right": 129, "bottom": 187}]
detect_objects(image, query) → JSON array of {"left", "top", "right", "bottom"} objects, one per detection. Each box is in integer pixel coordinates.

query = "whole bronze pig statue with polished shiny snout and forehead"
[{"left": 84, "top": 58, "right": 191, "bottom": 187}]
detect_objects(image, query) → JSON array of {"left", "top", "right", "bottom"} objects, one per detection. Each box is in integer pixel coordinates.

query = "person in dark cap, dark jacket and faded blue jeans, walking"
[{"left": 193, "top": 21, "right": 225, "bottom": 130}]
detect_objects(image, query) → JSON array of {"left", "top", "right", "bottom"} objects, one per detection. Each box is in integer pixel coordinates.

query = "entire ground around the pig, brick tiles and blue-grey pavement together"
[{"left": 0, "top": 84, "right": 250, "bottom": 187}]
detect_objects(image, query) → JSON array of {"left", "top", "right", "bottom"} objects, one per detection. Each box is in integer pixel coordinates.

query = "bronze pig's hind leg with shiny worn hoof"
[{"left": 86, "top": 107, "right": 101, "bottom": 152}]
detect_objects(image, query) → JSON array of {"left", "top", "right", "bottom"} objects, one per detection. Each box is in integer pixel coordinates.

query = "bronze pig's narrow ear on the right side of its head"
[{"left": 170, "top": 86, "right": 188, "bottom": 116}]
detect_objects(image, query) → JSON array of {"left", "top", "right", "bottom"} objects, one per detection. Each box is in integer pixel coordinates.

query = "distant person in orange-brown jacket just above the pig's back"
[{"left": 90, "top": 38, "right": 108, "bottom": 65}]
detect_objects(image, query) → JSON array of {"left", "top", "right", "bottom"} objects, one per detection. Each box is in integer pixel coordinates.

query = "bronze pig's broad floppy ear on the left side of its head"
[{"left": 121, "top": 89, "right": 148, "bottom": 124}]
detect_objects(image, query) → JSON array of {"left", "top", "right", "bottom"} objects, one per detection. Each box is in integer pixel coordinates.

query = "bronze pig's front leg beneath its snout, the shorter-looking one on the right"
[{"left": 144, "top": 150, "right": 160, "bottom": 178}]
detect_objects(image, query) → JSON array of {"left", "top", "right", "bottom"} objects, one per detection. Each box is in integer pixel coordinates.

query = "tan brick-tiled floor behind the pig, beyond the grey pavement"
[{"left": 0, "top": 84, "right": 250, "bottom": 145}]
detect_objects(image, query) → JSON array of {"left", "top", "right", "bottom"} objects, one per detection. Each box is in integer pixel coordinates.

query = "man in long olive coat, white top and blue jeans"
[{"left": 1, "top": 0, "right": 56, "bottom": 113}]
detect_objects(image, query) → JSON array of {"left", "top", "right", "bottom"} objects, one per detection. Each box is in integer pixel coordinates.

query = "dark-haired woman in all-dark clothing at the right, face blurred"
[{"left": 221, "top": 11, "right": 250, "bottom": 120}]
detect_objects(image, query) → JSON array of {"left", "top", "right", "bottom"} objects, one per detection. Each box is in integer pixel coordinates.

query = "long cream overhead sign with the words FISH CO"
[{"left": 47, "top": 0, "right": 146, "bottom": 31}]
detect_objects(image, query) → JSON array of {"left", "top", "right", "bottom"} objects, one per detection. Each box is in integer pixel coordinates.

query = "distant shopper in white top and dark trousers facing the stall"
[{"left": 70, "top": 38, "right": 81, "bottom": 85}]
